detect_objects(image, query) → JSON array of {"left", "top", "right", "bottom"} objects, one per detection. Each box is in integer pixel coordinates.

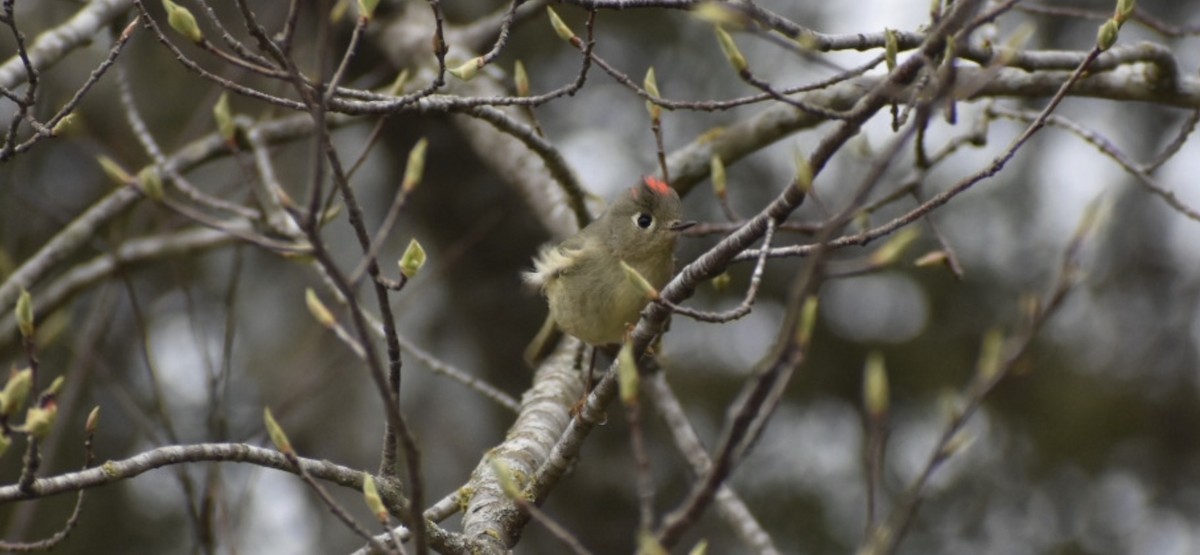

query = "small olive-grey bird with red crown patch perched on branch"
[{"left": 524, "top": 177, "right": 695, "bottom": 365}]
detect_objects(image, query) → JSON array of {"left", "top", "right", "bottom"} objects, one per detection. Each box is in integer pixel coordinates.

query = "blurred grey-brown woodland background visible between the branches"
[{"left": 0, "top": 0, "right": 1200, "bottom": 554}]
